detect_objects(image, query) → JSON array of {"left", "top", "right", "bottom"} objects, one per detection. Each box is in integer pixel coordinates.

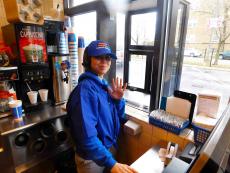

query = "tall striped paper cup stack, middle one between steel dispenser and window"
[{"left": 68, "top": 32, "right": 78, "bottom": 89}]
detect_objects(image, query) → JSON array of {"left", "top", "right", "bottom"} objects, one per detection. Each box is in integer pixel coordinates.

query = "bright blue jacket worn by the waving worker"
[{"left": 67, "top": 71, "right": 125, "bottom": 168}]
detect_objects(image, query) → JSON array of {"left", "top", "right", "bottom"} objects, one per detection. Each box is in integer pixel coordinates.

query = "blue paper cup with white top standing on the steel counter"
[{"left": 9, "top": 100, "right": 22, "bottom": 119}]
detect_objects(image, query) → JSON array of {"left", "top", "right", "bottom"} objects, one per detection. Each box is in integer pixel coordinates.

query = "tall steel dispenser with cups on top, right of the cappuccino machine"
[{"left": 44, "top": 21, "right": 71, "bottom": 105}]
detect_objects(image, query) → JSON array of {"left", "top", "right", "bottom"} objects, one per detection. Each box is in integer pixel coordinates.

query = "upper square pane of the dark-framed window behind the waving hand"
[{"left": 131, "top": 12, "right": 157, "bottom": 46}]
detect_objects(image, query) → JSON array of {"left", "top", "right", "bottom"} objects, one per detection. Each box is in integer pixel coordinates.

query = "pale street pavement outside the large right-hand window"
[{"left": 180, "top": 65, "right": 230, "bottom": 114}]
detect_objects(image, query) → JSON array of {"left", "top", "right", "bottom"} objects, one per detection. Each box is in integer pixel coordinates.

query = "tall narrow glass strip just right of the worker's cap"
[{"left": 116, "top": 13, "right": 125, "bottom": 79}]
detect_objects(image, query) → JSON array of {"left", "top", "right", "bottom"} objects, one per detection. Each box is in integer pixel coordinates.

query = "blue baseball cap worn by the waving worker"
[{"left": 87, "top": 40, "right": 117, "bottom": 59}]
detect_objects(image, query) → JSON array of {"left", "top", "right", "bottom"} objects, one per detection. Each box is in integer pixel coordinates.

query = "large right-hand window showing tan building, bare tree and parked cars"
[{"left": 180, "top": 0, "right": 230, "bottom": 116}]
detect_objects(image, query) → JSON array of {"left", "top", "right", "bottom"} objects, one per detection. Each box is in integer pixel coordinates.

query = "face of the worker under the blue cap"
[{"left": 90, "top": 55, "right": 111, "bottom": 77}]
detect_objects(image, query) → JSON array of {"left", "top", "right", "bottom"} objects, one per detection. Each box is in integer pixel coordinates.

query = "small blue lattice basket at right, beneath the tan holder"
[{"left": 192, "top": 124, "right": 211, "bottom": 144}]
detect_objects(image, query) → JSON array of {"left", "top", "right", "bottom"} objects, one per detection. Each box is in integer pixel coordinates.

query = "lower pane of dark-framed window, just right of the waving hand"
[{"left": 129, "top": 55, "right": 147, "bottom": 89}]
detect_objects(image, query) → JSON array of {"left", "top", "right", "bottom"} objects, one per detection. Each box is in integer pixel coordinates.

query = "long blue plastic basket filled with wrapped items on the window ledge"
[{"left": 149, "top": 116, "right": 189, "bottom": 135}]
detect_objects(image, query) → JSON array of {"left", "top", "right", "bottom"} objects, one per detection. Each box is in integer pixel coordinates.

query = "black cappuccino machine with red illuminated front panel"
[{"left": 2, "top": 23, "right": 50, "bottom": 112}]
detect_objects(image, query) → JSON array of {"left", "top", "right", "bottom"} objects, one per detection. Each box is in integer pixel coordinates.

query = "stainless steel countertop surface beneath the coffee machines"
[{"left": 0, "top": 105, "right": 66, "bottom": 136}]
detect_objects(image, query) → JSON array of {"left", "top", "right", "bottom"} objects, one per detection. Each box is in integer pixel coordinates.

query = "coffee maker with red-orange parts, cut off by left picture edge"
[{"left": 0, "top": 67, "right": 18, "bottom": 118}]
